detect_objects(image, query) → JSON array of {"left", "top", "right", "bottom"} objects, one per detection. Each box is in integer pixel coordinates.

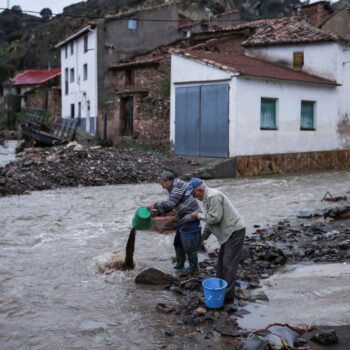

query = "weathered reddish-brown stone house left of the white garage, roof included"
[{"left": 107, "top": 24, "right": 253, "bottom": 150}]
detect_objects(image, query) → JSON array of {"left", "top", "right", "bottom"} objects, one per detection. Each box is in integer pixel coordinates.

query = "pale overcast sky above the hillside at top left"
[{"left": 0, "top": 0, "right": 337, "bottom": 14}]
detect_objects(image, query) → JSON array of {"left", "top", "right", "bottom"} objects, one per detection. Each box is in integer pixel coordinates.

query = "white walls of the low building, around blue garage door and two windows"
[{"left": 170, "top": 54, "right": 344, "bottom": 157}]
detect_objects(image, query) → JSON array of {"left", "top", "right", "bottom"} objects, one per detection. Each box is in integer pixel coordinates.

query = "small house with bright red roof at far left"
[{"left": 3, "top": 68, "right": 61, "bottom": 117}]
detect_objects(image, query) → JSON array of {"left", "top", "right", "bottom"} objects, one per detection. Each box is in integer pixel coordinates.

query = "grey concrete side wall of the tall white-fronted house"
[{"left": 98, "top": 4, "right": 180, "bottom": 108}]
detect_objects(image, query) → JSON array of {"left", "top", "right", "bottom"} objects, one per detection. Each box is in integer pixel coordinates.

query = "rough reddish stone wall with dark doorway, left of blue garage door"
[{"left": 108, "top": 58, "right": 170, "bottom": 149}]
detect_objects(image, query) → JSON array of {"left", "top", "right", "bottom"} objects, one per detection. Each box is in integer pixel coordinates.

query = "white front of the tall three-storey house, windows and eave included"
[{"left": 56, "top": 25, "right": 98, "bottom": 135}]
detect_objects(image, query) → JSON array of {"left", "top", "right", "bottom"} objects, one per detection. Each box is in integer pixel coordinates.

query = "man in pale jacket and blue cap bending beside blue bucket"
[{"left": 187, "top": 178, "right": 246, "bottom": 302}]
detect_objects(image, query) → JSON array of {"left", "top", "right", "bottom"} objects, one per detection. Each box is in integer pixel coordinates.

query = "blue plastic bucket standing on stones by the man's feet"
[{"left": 202, "top": 277, "right": 227, "bottom": 309}]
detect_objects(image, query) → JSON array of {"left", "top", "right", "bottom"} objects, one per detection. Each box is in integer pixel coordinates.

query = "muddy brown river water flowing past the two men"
[{"left": 0, "top": 168, "right": 350, "bottom": 349}]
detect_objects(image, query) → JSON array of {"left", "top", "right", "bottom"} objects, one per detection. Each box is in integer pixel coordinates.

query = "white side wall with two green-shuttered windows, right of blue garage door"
[{"left": 230, "top": 78, "right": 340, "bottom": 156}]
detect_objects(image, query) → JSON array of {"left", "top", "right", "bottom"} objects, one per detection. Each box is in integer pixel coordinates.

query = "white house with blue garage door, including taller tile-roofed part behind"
[{"left": 170, "top": 18, "right": 350, "bottom": 170}]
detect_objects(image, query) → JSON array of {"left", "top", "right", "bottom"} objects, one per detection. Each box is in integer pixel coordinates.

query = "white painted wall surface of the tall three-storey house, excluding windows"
[{"left": 61, "top": 29, "right": 98, "bottom": 130}]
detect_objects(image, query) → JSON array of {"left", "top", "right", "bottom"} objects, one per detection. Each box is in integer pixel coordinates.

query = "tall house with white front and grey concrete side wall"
[{"left": 56, "top": 2, "right": 241, "bottom": 143}]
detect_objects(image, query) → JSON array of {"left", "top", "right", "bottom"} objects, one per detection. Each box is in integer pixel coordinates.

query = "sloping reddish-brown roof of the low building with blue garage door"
[{"left": 172, "top": 50, "right": 338, "bottom": 86}]
